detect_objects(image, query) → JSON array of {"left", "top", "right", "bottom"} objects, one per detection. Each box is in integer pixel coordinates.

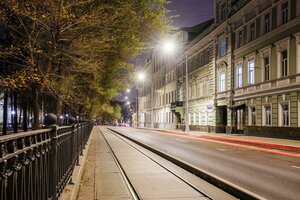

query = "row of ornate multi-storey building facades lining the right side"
[{"left": 139, "top": 0, "right": 300, "bottom": 138}]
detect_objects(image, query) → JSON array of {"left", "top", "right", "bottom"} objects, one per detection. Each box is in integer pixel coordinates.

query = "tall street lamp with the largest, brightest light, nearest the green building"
[{"left": 162, "top": 40, "right": 190, "bottom": 132}]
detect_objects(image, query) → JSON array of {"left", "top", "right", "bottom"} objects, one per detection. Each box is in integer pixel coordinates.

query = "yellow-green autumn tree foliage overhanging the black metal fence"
[{"left": 0, "top": 0, "right": 167, "bottom": 128}]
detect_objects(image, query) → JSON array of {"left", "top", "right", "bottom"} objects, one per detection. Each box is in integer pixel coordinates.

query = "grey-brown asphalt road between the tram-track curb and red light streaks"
[{"left": 113, "top": 127, "right": 300, "bottom": 200}]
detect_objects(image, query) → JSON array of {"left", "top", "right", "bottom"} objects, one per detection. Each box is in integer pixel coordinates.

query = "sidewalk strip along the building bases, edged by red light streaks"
[{"left": 141, "top": 128, "right": 300, "bottom": 153}]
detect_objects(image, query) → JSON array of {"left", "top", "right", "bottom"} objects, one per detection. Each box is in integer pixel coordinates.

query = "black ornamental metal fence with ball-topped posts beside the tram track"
[{"left": 0, "top": 122, "right": 93, "bottom": 200}]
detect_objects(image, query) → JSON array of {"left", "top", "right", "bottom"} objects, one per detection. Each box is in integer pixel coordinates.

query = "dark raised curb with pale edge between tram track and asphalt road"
[{"left": 108, "top": 128, "right": 266, "bottom": 200}]
